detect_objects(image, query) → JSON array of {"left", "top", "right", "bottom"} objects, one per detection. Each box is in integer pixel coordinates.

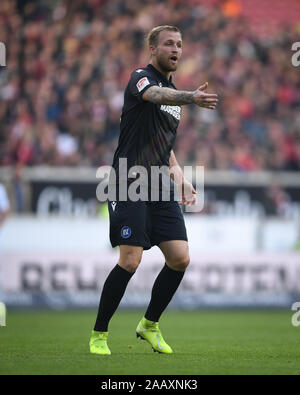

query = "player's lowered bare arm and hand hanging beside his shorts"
[{"left": 169, "top": 150, "right": 196, "bottom": 205}]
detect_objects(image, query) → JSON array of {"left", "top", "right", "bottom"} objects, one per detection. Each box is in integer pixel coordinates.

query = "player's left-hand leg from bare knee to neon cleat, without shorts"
[{"left": 90, "top": 245, "right": 143, "bottom": 355}]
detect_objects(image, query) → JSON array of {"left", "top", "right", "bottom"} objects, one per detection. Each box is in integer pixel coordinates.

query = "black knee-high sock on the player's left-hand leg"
[{"left": 94, "top": 265, "right": 134, "bottom": 332}]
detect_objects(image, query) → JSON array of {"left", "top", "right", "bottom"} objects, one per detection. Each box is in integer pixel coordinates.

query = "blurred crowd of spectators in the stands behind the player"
[{"left": 0, "top": 0, "right": 300, "bottom": 171}]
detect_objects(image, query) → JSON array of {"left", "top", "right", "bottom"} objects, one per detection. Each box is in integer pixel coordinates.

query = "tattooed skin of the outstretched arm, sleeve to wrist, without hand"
[{"left": 143, "top": 86, "right": 194, "bottom": 106}]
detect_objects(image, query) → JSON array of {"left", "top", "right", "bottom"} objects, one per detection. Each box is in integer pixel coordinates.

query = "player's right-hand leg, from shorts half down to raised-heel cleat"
[{"left": 136, "top": 201, "right": 189, "bottom": 354}]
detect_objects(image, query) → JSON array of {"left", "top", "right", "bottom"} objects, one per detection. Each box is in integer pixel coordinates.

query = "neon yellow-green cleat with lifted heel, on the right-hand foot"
[{"left": 136, "top": 317, "right": 173, "bottom": 354}]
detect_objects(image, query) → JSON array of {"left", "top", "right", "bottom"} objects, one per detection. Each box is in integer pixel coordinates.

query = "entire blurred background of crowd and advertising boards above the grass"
[{"left": 0, "top": 0, "right": 300, "bottom": 309}]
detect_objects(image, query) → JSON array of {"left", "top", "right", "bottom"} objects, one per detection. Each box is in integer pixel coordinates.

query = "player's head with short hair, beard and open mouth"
[{"left": 150, "top": 30, "right": 182, "bottom": 72}]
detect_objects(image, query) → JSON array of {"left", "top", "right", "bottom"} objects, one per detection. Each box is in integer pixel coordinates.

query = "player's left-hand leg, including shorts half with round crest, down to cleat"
[{"left": 90, "top": 200, "right": 151, "bottom": 354}]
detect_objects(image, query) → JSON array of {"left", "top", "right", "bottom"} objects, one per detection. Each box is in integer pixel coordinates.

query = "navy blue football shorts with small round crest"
[{"left": 108, "top": 200, "right": 188, "bottom": 250}]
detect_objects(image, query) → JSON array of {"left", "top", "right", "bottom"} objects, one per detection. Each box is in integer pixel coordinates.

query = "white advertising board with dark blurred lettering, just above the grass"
[{"left": 0, "top": 250, "right": 300, "bottom": 308}]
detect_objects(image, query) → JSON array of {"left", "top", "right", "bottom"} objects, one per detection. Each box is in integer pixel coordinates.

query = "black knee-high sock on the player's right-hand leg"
[{"left": 145, "top": 264, "right": 184, "bottom": 322}]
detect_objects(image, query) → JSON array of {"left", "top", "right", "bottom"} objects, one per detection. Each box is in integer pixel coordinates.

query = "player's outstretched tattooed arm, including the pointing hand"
[{"left": 142, "top": 82, "right": 218, "bottom": 110}]
